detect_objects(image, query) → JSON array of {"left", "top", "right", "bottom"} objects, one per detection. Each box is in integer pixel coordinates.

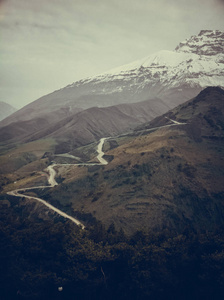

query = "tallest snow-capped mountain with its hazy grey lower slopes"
[{"left": 0, "top": 30, "right": 224, "bottom": 126}]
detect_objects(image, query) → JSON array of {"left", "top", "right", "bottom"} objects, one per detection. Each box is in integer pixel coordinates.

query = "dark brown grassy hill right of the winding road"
[{"left": 42, "top": 88, "right": 224, "bottom": 233}]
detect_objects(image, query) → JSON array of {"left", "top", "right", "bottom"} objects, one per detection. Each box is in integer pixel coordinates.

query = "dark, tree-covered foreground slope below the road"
[{"left": 0, "top": 197, "right": 224, "bottom": 300}]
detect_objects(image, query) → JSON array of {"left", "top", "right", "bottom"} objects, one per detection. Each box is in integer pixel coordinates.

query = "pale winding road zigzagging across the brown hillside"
[{"left": 7, "top": 117, "right": 187, "bottom": 229}]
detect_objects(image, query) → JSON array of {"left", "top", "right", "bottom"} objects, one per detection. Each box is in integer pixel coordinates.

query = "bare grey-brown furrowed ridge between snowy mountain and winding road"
[{"left": 0, "top": 98, "right": 168, "bottom": 153}]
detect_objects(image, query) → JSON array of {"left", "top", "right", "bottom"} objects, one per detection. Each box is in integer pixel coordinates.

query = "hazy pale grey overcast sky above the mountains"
[{"left": 0, "top": 0, "right": 224, "bottom": 108}]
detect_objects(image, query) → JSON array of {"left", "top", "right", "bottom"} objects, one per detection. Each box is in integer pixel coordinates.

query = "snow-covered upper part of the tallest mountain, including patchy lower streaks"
[{"left": 66, "top": 30, "right": 224, "bottom": 98}]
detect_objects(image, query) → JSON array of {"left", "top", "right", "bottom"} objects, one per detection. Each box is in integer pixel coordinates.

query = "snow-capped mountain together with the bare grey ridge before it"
[{"left": 0, "top": 30, "right": 224, "bottom": 153}]
